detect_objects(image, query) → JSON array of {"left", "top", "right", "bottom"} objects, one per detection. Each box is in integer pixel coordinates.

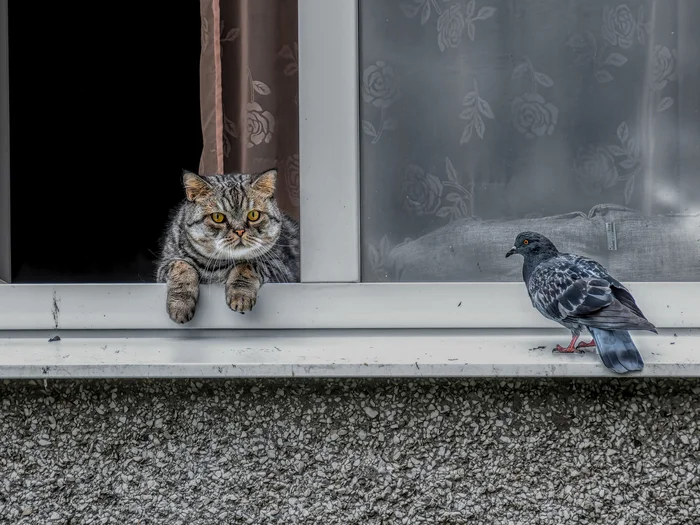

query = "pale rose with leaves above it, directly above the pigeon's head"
[{"left": 511, "top": 56, "right": 559, "bottom": 139}]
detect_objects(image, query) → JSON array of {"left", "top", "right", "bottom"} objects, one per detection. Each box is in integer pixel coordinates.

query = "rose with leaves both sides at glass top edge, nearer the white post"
[{"left": 400, "top": 0, "right": 496, "bottom": 51}]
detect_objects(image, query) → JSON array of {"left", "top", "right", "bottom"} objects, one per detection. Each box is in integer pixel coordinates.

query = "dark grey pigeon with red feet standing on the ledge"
[{"left": 506, "top": 232, "right": 658, "bottom": 374}]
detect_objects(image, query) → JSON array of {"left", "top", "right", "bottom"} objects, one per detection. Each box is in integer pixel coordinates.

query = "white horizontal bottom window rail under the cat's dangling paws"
[{"left": 0, "top": 282, "right": 700, "bottom": 331}]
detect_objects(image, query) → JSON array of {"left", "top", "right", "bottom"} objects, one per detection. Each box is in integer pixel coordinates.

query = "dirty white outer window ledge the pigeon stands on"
[{"left": 0, "top": 329, "right": 700, "bottom": 379}]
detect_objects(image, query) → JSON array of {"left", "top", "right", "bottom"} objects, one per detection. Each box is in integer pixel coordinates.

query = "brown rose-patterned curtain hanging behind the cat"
[{"left": 199, "top": 0, "right": 299, "bottom": 218}]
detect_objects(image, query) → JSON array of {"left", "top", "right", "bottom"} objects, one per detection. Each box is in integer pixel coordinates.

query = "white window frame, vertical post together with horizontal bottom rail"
[{"left": 0, "top": 0, "right": 700, "bottom": 376}]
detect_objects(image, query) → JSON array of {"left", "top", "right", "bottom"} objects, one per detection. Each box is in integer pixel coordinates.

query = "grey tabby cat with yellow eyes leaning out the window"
[{"left": 156, "top": 169, "right": 300, "bottom": 324}]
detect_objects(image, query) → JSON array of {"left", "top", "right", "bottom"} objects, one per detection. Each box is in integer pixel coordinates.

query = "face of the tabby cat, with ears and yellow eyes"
[{"left": 183, "top": 170, "right": 282, "bottom": 260}]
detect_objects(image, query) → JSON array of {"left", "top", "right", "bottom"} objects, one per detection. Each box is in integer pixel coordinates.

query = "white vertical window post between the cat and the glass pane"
[{"left": 299, "top": 0, "right": 360, "bottom": 283}]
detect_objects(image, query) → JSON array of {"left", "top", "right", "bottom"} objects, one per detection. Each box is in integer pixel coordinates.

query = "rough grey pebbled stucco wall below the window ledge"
[{"left": 0, "top": 378, "right": 700, "bottom": 525}]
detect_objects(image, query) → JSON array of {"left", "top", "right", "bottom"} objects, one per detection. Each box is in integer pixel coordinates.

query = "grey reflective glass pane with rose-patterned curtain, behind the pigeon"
[{"left": 360, "top": 0, "right": 700, "bottom": 281}]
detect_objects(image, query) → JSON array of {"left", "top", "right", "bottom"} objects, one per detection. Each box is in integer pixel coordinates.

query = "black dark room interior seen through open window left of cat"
[{"left": 9, "top": 0, "right": 202, "bottom": 283}]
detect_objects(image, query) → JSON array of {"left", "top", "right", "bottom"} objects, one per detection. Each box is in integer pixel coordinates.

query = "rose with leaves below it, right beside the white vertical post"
[{"left": 362, "top": 60, "right": 401, "bottom": 144}]
